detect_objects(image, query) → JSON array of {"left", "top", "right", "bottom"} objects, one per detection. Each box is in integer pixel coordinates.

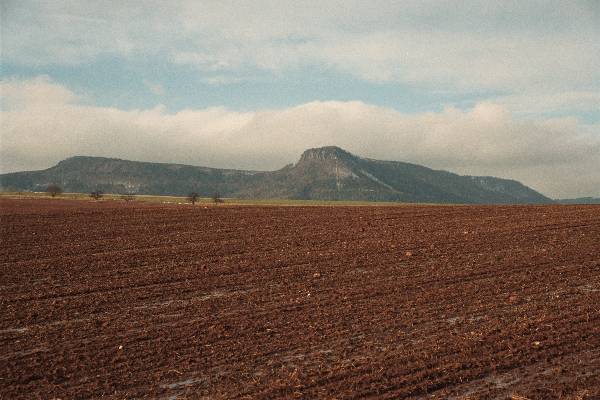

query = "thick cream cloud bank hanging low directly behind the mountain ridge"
[{"left": 0, "top": 77, "right": 600, "bottom": 197}]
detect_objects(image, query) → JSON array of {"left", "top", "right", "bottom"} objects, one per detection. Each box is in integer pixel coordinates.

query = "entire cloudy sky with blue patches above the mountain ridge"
[{"left": 0, "top": 0, "right": 600, "bottom": 198}]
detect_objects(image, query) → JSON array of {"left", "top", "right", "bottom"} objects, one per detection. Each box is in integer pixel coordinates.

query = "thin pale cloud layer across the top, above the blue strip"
[{"left": 2, "top": 0, "right": 600, "bottom": 113}]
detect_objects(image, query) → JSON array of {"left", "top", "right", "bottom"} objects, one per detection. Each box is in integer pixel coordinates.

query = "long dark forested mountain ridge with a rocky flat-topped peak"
[{"left": 0, "top": 146, "right": 553, "bottom": 204}]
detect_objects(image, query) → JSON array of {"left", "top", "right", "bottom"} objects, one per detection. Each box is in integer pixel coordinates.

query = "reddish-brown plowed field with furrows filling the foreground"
[{"left": 0, "top": 199, "right": 600, "bottom": 399}]
